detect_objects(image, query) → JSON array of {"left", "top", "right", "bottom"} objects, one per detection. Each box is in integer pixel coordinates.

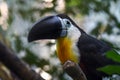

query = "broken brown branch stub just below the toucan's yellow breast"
[{"left": 63, "top": 60, "right": 87, "bottom": 80}]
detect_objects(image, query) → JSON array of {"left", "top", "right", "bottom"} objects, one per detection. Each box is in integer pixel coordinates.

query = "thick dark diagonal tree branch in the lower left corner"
[{"left": 0, "top": 42, "right": 44, "bottom": 80}]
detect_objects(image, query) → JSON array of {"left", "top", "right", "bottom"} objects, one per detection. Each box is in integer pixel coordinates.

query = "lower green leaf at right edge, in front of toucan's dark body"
[{"left": 97, "top": 65, "right": 120, "bottom": 75}]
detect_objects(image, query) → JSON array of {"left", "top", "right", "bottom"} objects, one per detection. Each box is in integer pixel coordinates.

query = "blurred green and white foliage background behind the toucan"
[{"left": 0, "top": 0, "right": 120, "bottom": 80}]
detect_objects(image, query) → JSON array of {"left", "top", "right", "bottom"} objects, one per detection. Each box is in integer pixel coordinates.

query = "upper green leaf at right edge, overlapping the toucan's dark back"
[{"left": 106, "top": 50, "right": 120, "bottom": 62}]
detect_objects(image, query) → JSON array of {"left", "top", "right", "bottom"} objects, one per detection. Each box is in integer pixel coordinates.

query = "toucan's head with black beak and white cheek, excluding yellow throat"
[{"left": 28, "top": 14, "right": 84, "bottom": 42}]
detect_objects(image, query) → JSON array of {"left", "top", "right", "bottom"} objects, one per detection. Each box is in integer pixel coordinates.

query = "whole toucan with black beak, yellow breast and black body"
[{"left": 28, "top": 14, "right": 119, "bottom": 80}]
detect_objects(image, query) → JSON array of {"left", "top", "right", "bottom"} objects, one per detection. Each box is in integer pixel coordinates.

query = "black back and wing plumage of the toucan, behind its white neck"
[{"left": 77, "top": 33, "right": 116, "bottom": 80}]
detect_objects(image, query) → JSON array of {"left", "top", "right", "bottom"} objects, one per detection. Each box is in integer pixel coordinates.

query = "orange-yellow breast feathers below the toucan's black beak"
[{"left": 57, "top": 37, "right": 79, "bottom": 64}]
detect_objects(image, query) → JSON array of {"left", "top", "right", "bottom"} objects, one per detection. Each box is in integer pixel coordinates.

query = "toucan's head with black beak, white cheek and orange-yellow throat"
[{"left": 28, "top": 14, "right": 84, "bottom": 63}]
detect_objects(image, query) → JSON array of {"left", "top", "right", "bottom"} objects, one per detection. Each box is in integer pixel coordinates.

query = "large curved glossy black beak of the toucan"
[{"left": 28, "top": 16, "right": 62, "bottom": 42}]
